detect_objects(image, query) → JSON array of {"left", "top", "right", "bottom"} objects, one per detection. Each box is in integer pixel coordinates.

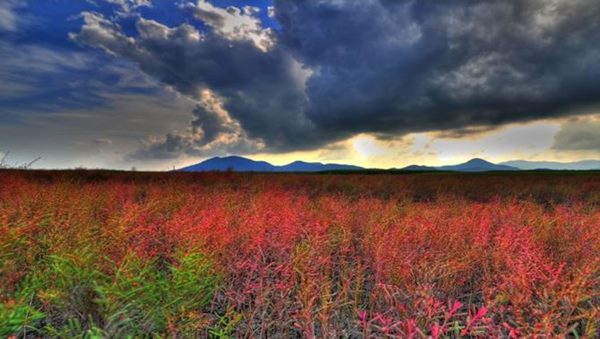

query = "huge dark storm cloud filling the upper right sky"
[{"left": 275, "top": 0, "right": 600, "bottom": 133}]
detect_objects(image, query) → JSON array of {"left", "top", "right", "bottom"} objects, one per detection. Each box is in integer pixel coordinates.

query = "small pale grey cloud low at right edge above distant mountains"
[{"left": 552, "top": 117, "right": 600, "bottom": 152}]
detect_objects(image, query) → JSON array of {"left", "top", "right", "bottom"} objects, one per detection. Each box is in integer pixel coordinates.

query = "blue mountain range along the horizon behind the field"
[{"left": 180, "top": 156, "right": 600, "bottom": 172}]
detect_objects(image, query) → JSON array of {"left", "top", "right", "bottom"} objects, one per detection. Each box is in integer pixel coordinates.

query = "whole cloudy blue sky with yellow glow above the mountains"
[{"left": 0, "top": 0, "right": 600, "bottom": 170}]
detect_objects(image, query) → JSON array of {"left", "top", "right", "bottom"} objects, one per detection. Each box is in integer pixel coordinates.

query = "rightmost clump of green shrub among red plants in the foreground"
[{"left": 97, "top": 253, "right": 220, "bottom": 336}]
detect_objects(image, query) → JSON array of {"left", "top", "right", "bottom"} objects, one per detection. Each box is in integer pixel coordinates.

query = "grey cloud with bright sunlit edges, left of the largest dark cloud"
[{"left": 71, "top": 7, "right": 317, "bottom": 156}]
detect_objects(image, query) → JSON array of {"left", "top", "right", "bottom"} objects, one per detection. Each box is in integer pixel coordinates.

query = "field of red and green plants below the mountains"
[{"left": 0, "top": 171, "right": 600, "bottom": 338}]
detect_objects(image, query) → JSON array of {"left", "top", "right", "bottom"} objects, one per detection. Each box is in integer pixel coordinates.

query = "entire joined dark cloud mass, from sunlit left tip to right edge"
[{"left": 73, "top": 0, "right": 600, "bottom": 156}]
